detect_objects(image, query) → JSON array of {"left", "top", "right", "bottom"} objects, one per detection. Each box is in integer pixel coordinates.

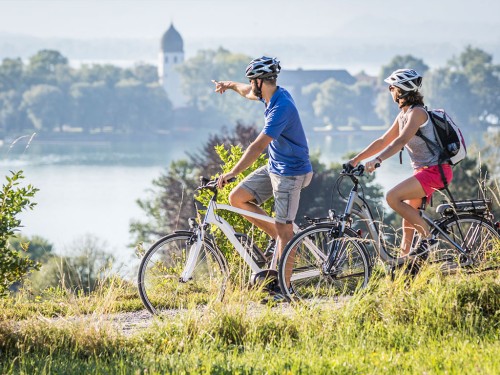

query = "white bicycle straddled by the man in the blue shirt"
[{"left": 138, "top": 178, "right": 288, "bottom": 314}]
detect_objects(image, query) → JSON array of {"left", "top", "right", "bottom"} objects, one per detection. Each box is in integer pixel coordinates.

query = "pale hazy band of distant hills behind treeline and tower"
[{"left": 0, "top": 34, "right": 500, "bottom": 75}]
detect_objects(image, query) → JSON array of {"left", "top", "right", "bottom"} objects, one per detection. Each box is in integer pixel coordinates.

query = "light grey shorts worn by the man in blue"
[{"left": 237, "top": 165, "right": 313, "bottom": 224}]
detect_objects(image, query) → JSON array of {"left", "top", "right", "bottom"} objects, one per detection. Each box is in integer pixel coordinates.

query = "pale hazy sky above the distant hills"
[{"left": 0, "top": 0, "right": 500, "bottom": 43}]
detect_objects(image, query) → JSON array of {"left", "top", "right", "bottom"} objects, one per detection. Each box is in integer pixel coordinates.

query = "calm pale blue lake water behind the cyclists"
[{"left": 0, "top": 128, "right": 484, "bottom": 274}]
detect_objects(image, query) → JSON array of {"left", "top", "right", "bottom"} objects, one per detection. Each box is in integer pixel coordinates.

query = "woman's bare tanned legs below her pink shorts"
[{"left": 386, "top": 177, "right": 430, "bottom": 255}]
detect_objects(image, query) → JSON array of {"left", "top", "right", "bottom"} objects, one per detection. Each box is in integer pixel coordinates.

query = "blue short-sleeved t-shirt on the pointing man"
[{"left": 262, "top": 86, "right": 312, "bottom": 176}]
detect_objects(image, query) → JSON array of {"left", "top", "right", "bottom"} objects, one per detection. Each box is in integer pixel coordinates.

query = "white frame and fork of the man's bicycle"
[{"left": 181, "top": 197, "right": 299, "bottom": 282}]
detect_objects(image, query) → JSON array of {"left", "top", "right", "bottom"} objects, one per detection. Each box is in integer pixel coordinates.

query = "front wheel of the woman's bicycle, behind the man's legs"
[{"left": 279, "top": 223, "right": 371, "bottom": 300}]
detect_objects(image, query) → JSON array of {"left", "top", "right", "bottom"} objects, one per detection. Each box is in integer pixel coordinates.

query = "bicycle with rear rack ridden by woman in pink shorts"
[{"left": 278, "top": 165, "right": 500, "bottom": 299}]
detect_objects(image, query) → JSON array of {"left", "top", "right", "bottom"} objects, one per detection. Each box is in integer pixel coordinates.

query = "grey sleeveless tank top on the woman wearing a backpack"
[{"left": 398, "top": 107, "right": 439, "bottom": 169}]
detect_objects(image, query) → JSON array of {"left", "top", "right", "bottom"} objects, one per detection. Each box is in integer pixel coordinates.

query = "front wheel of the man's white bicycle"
[{"left": 138, "top": 232, "right": 228, "bottom": 314}]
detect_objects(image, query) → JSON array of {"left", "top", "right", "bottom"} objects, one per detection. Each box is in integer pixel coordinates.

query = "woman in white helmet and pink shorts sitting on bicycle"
[{"left": 349, "top": 69, "right": 453, "bottom": 257}]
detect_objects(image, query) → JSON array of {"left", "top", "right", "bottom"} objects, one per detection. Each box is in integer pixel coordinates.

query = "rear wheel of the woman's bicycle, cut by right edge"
[{"left": 434, "top": 214, "right": 500, "bottom": 271}]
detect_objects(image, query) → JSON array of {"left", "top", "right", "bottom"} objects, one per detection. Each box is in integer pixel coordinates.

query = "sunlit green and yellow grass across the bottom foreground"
[{"left": 0, "top": 269, "right": 500, "bottom": 374}]
